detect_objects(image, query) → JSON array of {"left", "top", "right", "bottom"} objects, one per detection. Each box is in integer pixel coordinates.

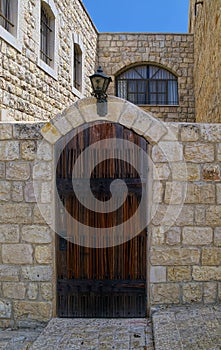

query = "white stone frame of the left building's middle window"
[{"left": 37, "top": 0, "right": 58, "bottom": 80}]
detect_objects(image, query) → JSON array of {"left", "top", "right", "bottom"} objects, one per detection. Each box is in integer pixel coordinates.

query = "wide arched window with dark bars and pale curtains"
[{"left": 116, "top": 65, "right": 178, "bottom": 105}]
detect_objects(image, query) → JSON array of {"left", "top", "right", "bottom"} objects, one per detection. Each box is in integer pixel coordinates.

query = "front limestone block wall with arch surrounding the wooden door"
[{"left": 0, "top": 97, "right": 221, "bottom": 326}]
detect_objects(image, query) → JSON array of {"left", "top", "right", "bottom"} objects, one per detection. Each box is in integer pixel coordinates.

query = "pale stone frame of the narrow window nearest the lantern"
[{"left": 71, "top": 33, "right": 85, "bottom": 98}]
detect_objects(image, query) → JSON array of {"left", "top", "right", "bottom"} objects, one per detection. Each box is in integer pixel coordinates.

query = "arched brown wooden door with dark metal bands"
[{"left": 56, "top": 122, "right": 147, "bottom": 317}]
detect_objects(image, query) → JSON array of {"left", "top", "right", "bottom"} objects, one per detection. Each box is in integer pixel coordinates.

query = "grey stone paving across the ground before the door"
[{"left": 0, "top": 305, "right": 221, "bottom": 350}]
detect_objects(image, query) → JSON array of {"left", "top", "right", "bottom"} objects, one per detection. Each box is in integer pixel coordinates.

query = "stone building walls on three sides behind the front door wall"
[{"left": 0, "top": 0, "right": 221, "bottom": 122}]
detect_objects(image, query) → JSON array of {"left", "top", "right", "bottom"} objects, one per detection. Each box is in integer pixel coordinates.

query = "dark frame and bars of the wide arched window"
[{"left": 116, "top": 64, "right": 179, "bottom": 106}]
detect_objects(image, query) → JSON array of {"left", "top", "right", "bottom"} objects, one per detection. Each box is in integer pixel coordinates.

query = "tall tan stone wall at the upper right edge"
[{"left": 189, "top": 0, "right": 221, "bottom": 123}]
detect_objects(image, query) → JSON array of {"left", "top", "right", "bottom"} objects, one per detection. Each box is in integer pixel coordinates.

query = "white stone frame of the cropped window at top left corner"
[{"left": 0, "top": 0, "right": 24, "bottom": 53}]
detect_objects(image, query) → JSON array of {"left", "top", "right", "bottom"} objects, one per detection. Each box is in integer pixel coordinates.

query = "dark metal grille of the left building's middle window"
[{"left": 40, "top": 6, "right": 53, "bottom": 65}]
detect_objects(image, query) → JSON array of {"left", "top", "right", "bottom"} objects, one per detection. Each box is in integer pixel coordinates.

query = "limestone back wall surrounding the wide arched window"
[{"left": 98, "top": 33, "right": 195, "bottom": 122}]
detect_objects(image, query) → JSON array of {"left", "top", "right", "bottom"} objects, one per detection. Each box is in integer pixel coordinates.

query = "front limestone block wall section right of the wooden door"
[{"left": 150, "top": 123, "right": 221, "bottom": 305}]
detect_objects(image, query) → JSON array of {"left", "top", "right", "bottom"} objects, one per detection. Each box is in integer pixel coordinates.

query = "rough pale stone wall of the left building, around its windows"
[{"left": 0, "top": 0, "right": 97, "bottom": 121}]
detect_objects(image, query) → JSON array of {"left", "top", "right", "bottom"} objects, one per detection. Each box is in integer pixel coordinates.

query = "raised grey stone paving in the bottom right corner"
[{"left": 153, "top": 305, "right": 221, "bottom": 350}]
